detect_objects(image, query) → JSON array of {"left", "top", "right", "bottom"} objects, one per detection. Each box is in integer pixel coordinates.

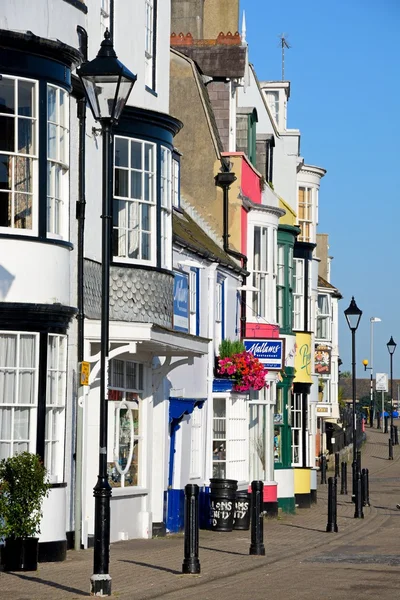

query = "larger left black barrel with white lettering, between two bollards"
[{"left": 210, "top": 479, "right": 237, "bottom": 531}]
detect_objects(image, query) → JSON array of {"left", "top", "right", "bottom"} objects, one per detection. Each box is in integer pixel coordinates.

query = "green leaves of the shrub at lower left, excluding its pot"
[{"left": 0, "top": 452, "right": 50, "bottom": 538}]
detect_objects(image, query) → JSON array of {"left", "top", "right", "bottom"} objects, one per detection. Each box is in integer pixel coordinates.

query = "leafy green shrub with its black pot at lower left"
[{"left": 0, "top": 452, "right": 50, "bottom": 571}]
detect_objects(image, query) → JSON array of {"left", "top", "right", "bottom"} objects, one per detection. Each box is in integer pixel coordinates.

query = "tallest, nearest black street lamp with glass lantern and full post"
[{"left": 77, "top": 30, "right": 136, "bottom": 596}]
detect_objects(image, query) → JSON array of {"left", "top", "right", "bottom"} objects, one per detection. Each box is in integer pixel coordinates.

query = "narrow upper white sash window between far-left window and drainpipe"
[{"left": 47, "top": 85, "right": 69, "bottom": 237}]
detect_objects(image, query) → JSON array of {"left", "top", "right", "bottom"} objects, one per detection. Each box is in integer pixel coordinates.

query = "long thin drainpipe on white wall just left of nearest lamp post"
[{"left": 74, "top": 98, "right": 86, "bottom": 550}]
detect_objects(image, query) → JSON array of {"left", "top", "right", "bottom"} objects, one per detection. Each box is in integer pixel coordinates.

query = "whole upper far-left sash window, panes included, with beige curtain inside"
[{"left": 0, "top": 75, "right": 38, "bottom": 233}]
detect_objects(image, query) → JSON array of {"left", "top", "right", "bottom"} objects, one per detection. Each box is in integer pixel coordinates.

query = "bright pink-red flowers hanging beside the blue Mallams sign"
[{"left": 217, "top": 351, "right": 268, "bottom": 392}]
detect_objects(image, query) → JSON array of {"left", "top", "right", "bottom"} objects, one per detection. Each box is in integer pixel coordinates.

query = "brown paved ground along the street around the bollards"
[{"left": 0, "top": 421, "right": 400, "bottom": 600}]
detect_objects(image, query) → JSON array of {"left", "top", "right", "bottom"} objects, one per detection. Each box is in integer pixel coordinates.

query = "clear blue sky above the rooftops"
[{"left": 241, "top": 0, "right": 400, "bottom": 378}]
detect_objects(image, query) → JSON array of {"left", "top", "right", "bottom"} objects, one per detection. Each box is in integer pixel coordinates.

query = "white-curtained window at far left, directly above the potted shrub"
[{"left": 0, "top": 332, "right": 39, "bottom": 459}]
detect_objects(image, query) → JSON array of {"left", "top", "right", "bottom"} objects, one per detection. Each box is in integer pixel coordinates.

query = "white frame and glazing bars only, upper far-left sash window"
[{"left": 0, "top": 74, "right": 40, "bottom": 237}]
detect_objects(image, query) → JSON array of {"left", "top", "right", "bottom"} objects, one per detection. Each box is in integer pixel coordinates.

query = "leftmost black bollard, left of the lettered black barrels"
[{"left": 182, "top": 483, "right": 200, "bottom": 575}]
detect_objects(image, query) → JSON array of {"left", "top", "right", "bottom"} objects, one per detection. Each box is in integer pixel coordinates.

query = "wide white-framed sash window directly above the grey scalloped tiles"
[{"left": 113, "top": 136, "right": 156, "bottom": 264}]
